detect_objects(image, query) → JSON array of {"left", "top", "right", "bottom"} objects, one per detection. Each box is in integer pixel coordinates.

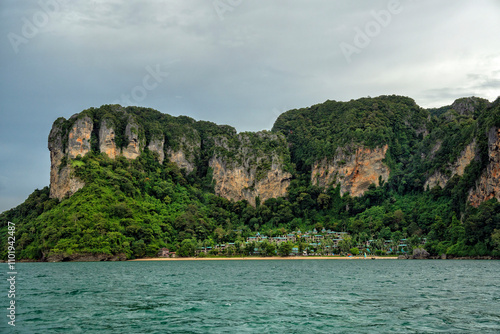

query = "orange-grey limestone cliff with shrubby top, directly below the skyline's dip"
[{"left": 209, "top": 132, "right": 292, "bottom": 206}]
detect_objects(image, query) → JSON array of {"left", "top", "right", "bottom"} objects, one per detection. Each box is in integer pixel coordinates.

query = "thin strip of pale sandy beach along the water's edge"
[{"left": 129, "top": 256, "right": 398, "bottom": 261}]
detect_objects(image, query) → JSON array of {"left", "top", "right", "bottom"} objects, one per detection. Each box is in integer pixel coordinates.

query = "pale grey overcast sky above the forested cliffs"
[{"left": 0, "top": 0, "right": 500, "bottom": 212}]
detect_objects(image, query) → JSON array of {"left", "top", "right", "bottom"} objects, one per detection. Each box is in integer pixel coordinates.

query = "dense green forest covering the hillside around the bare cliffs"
[{"left": 0, "top": 96, "right": 500, "bottom": 259}]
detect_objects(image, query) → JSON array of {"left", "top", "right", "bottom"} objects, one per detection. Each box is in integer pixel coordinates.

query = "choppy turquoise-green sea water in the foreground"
[{"left": 0, "top": 260, "right": 500, "bottom": 333}]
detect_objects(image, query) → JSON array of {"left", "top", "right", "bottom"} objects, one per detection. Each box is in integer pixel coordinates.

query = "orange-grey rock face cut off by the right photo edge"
[{"left": 468, "top": 127, "right": 500, "bottom": 207}]
